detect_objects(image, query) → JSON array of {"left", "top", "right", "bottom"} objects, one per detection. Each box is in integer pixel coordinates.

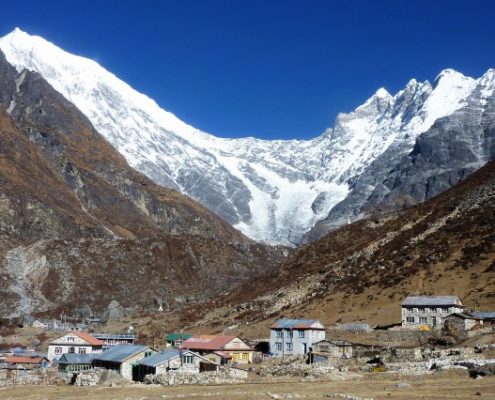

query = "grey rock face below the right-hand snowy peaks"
[{"left": 306, "top": 70, "right": 495, "bottom": 241}]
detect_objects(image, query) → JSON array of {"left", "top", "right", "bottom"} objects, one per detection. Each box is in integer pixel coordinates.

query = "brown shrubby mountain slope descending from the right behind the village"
[{"left": 191, "top": 157, "right": 495, "bottom": 334}]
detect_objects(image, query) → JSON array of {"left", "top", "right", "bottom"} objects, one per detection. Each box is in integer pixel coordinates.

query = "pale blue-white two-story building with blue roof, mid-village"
[{"left": 270, "top": 318, "right": 325, "bottom": 357}]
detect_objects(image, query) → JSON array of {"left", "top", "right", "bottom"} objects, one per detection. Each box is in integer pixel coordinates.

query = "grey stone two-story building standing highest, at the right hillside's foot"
[{"left": 401, "top": 296, "right": 464, "bottom": 328}]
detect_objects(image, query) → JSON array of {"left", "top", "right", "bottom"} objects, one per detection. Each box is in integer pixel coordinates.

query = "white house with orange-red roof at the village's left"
[{"left": 48, "top": 331, "right": 103, "bottom": 361}]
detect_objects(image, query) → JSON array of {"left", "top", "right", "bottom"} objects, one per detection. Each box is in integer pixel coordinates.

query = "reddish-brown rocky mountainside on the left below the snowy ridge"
[{"left": 0, "top": 50, "right": 281, "bottom": 317}]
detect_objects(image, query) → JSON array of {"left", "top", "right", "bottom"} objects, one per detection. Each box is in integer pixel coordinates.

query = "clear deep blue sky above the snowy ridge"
[{"left": 0, "top": 0, "right": 495, "bottom": 139}]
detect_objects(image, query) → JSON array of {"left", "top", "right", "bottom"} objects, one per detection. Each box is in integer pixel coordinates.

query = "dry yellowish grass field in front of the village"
[{"left": 0, "top": 371, "right": 495, "bottom": 400}]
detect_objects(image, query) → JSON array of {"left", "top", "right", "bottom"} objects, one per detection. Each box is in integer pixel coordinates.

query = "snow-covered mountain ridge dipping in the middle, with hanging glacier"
[{"left": 0, "top": 29, "right": 495, "bottom": 244}]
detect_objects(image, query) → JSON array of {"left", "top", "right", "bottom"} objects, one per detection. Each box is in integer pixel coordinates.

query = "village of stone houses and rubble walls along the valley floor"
[{"left": 0, "top": 296, "right": 495, "bottom": 394}]
